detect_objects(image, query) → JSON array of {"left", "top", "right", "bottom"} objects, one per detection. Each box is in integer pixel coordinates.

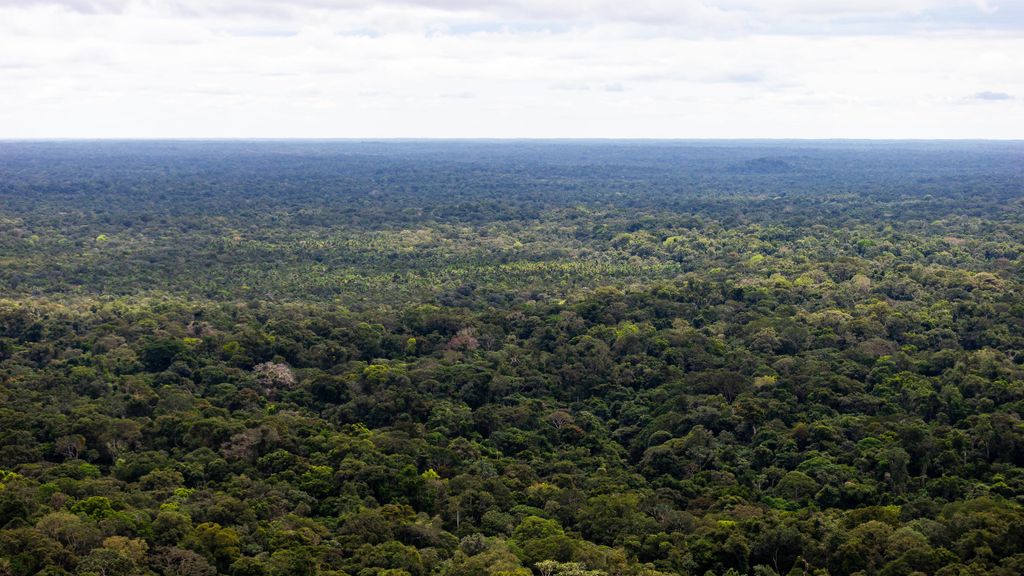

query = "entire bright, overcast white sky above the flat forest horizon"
[{"left": 0, "top": 0, "right": 1024, "bottom": 139}]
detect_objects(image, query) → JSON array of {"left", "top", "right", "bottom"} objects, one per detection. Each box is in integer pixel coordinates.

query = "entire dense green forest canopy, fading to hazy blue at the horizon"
[{"left": 0, "top": 141, "right": 1024, "bottom": 576}]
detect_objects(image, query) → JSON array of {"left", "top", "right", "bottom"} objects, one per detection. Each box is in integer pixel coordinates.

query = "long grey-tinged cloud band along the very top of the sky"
[{"left": 6, "top": 0, "right": 1024, "bottom": 35}]
